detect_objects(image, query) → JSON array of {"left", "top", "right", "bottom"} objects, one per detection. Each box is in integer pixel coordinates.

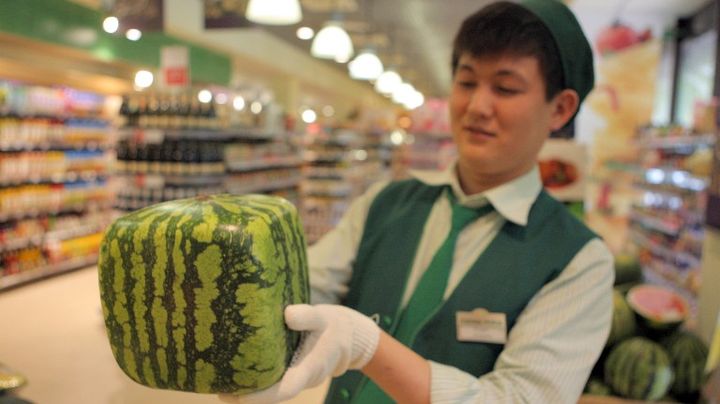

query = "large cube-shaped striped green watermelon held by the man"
[{"left": 98, "top": 195, "right": 309, "bottom": 393}]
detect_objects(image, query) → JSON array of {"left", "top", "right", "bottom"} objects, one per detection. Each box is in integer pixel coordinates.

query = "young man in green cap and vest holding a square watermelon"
[{"left": 225, "top": 0, "right": 613, "bottom": 404}]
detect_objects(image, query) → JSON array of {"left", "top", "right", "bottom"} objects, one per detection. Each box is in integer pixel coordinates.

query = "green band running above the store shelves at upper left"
[{"left": 0, "top": 0, "right": 232, "bottom": 85}]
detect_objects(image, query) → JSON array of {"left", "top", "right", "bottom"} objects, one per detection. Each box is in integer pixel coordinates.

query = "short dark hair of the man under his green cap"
[{"left": 452, "top": 1, "right": 565, "bottom": 100}]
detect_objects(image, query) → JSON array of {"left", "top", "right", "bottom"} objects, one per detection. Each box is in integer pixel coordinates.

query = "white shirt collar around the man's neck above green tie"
[{"left": 410, "top": 160, "right": 542, "bottom": 226}]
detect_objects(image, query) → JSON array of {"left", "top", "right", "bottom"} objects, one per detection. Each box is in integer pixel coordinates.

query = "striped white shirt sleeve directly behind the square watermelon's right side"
[{"left": 308, "top": 181, "right": 388, "bottom": 304}]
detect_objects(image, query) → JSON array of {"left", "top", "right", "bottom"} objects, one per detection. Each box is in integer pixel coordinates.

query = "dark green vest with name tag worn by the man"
[{"left": 325, "top": 179, "right": 596, "bottom": 404}]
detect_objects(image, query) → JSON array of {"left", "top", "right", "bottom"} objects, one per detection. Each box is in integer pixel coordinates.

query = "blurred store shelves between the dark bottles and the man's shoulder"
[{"left": 300, "top": 129, "right": 388, "bottom": 244}]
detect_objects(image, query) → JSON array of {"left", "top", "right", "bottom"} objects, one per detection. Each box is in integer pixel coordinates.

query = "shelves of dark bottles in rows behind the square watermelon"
[{"left": 116, "top": 93, "right": 301, "bottom": 211}]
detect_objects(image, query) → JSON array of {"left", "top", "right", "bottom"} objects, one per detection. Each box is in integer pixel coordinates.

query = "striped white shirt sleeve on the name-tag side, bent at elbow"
[{"left": 430, "top": 239, "right": 615, "bottom": 403}]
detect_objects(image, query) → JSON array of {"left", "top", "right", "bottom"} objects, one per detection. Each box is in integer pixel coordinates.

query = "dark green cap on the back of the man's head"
[{"left": 520, "top": 0, "right": 595, "bottom": 104}]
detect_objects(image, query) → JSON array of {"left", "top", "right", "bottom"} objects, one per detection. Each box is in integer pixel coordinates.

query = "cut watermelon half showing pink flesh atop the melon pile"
[{"left": 626, "top": 284, "right": 690, "bottom": 330}]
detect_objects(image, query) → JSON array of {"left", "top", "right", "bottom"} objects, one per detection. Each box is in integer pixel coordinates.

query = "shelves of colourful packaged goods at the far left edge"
[{"left": 0, "top": 80, "right": 115, "bottom": 290}]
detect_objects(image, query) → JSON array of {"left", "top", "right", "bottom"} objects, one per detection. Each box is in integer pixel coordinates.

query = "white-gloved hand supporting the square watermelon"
[{"left": 220, "top": 304, "right": 380, "bottom": 404}]
